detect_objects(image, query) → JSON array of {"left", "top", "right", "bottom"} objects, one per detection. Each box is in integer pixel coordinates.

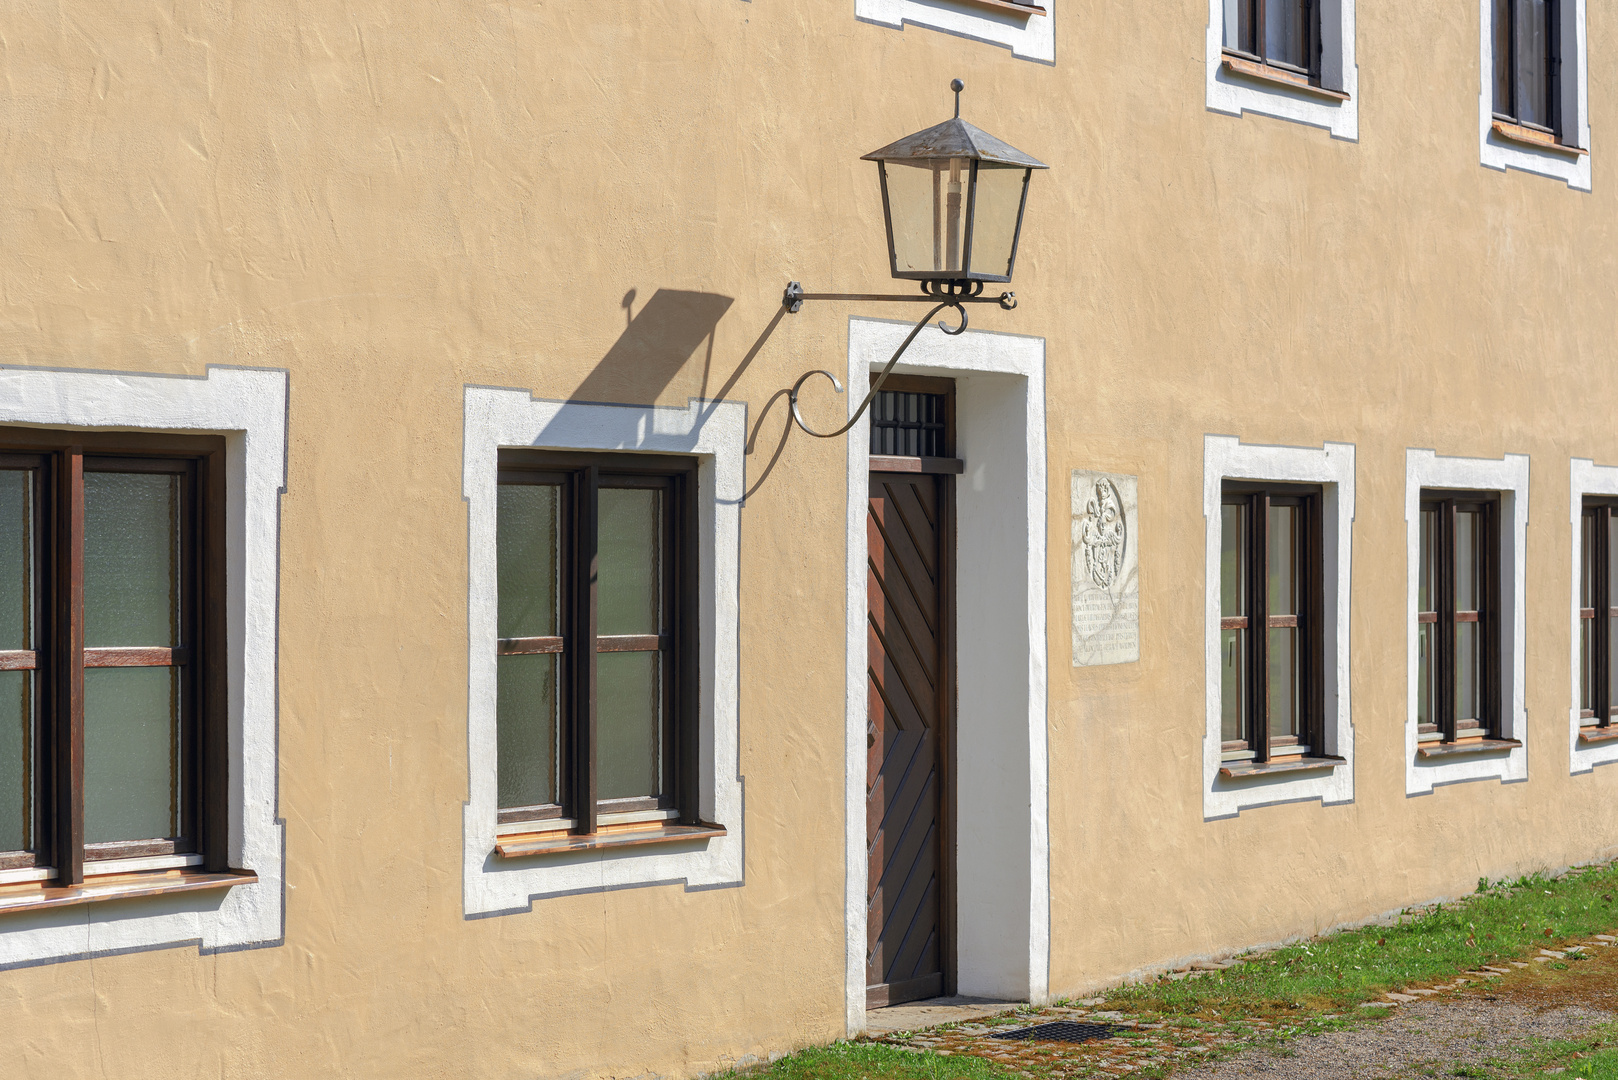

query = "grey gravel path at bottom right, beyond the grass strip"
[{"left": 1175, "top": 996, "right": 1615, "bottom": 1080}]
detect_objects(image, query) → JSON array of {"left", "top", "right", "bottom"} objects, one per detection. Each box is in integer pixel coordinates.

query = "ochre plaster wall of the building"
[{"left": 0, "top": 0, "right": 1618, "bottom": 1080}]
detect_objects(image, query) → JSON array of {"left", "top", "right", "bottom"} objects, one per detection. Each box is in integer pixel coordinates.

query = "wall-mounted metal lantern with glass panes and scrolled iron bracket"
[{"left": 781, "top": 79, "right": 1048, "bottom": 439}]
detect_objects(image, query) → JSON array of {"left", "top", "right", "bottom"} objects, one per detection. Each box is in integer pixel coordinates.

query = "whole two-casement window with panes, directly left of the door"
[{"left": 495, "top": 450, "right": 701, "bottom": 836}]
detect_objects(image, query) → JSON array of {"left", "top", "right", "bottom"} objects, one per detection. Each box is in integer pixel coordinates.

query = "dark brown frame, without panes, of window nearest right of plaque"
[{"left": 1220, "top": 479, "right": 1327, "bottom": 776}]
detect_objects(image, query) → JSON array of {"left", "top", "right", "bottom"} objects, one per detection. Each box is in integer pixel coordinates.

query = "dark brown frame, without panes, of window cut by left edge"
[{"left": 0, "top": 427, "right": 231, "bottom": 907}]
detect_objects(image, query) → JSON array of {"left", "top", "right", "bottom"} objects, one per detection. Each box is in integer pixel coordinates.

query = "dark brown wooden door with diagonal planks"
[{"left": 866, "top": 473, "right": 948, "bottom": 1009}]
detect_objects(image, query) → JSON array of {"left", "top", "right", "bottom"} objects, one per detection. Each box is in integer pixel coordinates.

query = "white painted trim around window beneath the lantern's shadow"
[{"left": 463, "top": 393, "right": 748, "bottom": 916}]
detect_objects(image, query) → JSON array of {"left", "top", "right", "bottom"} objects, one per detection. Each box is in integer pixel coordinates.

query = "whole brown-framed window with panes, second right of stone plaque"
[{"left": 1416, "top": 491, "right": 1500, "bottom": 748}]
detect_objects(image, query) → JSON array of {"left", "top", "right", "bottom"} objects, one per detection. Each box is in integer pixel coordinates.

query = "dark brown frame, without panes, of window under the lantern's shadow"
[{"left": 497, "top": 449, "right": 695, "bottom": 835}]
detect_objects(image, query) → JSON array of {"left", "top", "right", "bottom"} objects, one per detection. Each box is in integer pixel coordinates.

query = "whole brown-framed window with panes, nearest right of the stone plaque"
[{"left": 1220, "top": 481, "right": 1324, "bottom": 764}]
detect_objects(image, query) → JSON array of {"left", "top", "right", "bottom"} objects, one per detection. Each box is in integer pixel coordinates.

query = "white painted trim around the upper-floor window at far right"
[{"left": 1477, "top": 0, "right": 1590, "bottom": 191}]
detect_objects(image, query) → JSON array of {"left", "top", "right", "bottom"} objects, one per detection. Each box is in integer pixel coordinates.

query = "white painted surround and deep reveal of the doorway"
[{"left": 845, "top": 317, "right": 1050, "bottom": 1033}]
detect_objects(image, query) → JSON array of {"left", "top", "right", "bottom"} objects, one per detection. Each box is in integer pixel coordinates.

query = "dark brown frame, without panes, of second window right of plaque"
[{"left": 1411, "top": 489, "right": 1511, "bottom": 756}]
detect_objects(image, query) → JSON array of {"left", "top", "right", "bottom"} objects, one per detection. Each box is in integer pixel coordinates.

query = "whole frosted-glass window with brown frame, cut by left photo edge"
[{"left": 0, "top": 429, "right": 230, "bottom": 886}]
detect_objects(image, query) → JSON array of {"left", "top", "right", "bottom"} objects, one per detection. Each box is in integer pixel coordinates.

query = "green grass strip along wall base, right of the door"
[{"left": 1087, "top": 866, "right": 1618, "bottom": 1017}]
